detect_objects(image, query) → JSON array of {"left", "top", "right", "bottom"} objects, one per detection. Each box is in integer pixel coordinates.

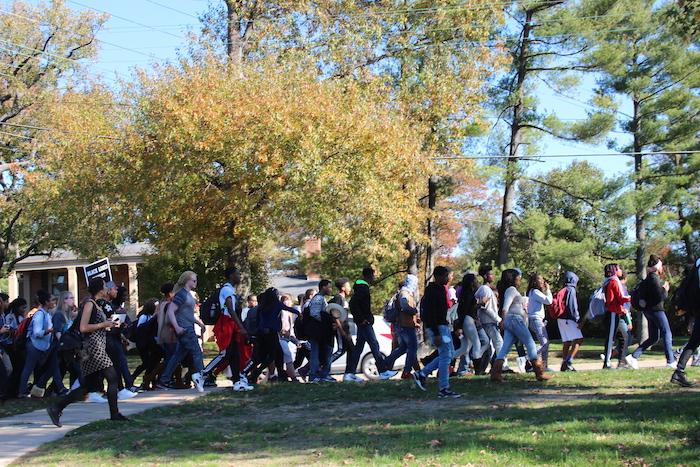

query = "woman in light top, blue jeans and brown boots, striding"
[{"left": 491, "top": 269, "right": 552, "bottom": 382}]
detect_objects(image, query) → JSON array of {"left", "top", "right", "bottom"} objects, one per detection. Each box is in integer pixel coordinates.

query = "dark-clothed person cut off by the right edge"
[{"left": 671, "top": 259, "right": 700, "bottom": 387}]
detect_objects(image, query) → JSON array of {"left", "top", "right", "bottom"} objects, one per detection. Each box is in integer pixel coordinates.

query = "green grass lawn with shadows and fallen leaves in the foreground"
[{"left": 17, "top": 368, "right": 700, "bottom": 466}]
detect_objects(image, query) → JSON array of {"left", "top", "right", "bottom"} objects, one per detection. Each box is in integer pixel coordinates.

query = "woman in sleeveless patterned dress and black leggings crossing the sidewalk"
[{"left": 46, "top": 277, "right": 129, "bottom": 427}]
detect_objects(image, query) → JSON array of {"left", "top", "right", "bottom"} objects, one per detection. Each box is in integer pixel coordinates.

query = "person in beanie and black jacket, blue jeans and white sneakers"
[{"left": 625, "top": 255, "right": 676, "bottom": 370}]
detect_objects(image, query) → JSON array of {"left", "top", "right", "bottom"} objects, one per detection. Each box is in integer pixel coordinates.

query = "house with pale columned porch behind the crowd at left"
[{"left": 8, "top": 243, "right": 153, "bottom": 309}]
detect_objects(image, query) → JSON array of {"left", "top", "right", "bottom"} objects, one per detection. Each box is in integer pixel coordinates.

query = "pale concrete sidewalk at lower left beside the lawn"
[{"left": 0, "top": 388, "right": 218, "bottom": 467}]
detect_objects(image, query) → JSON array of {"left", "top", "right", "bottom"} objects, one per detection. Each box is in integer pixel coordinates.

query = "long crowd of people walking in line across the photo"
[{"left": 0, "top": 255, "right": 700, "bottom": 426}]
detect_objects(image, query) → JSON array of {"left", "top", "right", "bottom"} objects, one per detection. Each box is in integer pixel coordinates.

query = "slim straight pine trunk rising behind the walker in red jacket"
[{"left": 632, "top": 96, "right": 649, "bottom": 342}]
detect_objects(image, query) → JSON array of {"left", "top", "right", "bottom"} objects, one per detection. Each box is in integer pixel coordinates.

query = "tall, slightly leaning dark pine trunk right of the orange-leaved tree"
[{"left": 497, "top": 10, "right": 533, "bottom": 266}]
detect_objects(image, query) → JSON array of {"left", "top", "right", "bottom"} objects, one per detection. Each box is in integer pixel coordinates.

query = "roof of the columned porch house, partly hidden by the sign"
[{"left": 15, "top": 242, "right": 155, "bottom": 272}]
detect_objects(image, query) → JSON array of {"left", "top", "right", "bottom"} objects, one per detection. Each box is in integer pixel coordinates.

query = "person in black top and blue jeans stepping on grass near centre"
[{"left": 413, "top": 266, "right": 462, "bottom": 399}]
